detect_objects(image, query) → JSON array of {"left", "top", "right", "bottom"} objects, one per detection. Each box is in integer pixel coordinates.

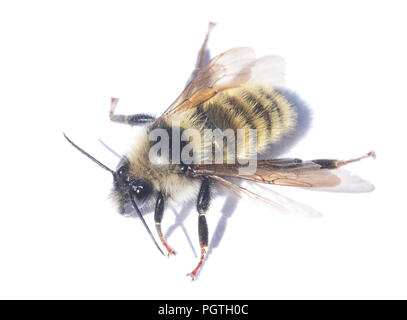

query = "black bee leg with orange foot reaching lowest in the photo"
[{"left": 188, "top": 178, "right": 211, "bottom": 280}]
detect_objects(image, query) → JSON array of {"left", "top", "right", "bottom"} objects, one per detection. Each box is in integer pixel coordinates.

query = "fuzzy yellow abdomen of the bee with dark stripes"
[{"left": 191, "top": 85, "right": 297, "bottom": 153}]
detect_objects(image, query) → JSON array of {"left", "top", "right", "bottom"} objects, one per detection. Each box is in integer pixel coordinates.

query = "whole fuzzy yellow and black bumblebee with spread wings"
[{"left": 64, "top": 23, "right": 375, "bottom": 279}]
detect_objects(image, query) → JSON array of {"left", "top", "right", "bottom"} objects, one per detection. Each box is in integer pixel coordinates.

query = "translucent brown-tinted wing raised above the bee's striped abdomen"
[{"left": 157, "top": 47, "right": 284, "bottom": 121}]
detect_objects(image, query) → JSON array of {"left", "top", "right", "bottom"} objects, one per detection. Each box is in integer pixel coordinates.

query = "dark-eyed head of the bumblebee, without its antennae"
[{"left": 113, "top": 158, "right": 154, "bottom": 214}]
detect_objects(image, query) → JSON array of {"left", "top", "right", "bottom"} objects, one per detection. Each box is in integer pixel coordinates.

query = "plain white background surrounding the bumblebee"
[{"left": 0, "top": 0, "right": 407, "bottom": 299}]
